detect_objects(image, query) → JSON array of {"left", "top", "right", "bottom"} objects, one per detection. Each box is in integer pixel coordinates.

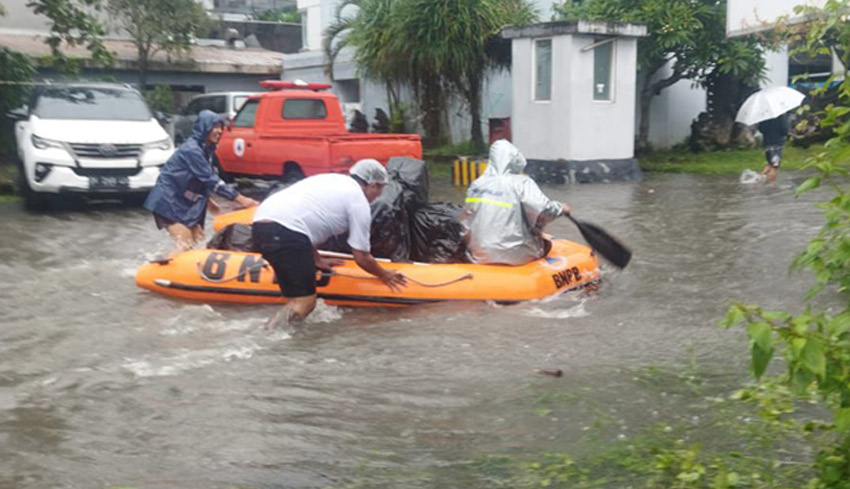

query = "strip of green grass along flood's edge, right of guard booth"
[{"left": 639, "top": 144, "right": 824, "bottom": 175}]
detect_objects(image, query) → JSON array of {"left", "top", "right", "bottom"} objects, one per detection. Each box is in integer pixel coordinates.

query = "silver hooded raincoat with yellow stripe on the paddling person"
[{"left": 460, "top": 139, "right": 563, "bottom": 265}]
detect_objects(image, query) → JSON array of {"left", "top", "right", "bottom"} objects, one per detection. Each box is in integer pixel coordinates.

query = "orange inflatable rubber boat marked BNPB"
[{"left": 136, "top": 208, "right": 599, "bottom": 306}]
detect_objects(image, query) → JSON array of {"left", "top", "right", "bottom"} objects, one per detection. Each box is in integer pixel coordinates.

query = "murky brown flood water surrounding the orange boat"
[{"left": 0, "top": 173, "right": 822, "bottom": 489}]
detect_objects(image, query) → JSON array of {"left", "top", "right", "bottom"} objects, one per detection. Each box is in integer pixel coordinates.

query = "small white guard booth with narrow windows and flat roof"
[{"left": 502, "top": 21, "right": 646, "bottom": 183}]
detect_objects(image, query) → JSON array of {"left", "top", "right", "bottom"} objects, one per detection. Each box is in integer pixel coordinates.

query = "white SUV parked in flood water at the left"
[{"left": 10, "top": 84, "right": 174, "bottom": 208}]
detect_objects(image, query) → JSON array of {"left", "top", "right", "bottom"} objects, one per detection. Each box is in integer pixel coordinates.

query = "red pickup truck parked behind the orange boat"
[{"left": 216, "top": 80, "right": 422, "bottom": 181}]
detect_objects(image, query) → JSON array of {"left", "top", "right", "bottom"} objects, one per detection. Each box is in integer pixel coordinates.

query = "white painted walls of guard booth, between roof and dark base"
[{"left": 511, "top": 35, "right": 637, "bottom": 160}]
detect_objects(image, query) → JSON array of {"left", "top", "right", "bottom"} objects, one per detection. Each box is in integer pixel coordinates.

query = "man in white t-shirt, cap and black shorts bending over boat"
[{"left": 252, "top": 159, "right": 407, "bottom": 325}]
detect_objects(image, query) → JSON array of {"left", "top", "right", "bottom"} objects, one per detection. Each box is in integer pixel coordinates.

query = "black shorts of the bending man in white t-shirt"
[{"left": 251, "top": 222, "right": 316, "bottom": 297}]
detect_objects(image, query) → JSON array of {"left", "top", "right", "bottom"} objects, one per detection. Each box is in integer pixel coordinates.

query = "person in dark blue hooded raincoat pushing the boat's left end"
[{"left": 145, "top": 110, "right": 257, "bottom": 255}]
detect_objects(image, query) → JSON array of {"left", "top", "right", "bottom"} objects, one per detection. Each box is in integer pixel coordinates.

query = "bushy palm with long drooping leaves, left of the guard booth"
[{"left": 325, "top": 0, "right": 537, "bottom": 148}]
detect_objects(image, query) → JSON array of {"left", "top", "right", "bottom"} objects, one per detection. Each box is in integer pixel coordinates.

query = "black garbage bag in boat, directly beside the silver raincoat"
[{"left": 410, "top": 202, "right": 468, "bottom": 263}]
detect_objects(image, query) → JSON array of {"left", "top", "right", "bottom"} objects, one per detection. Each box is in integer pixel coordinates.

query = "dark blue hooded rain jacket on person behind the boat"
[{"left": 145, "top": 110, "right": 239, "bottom": 228}]
